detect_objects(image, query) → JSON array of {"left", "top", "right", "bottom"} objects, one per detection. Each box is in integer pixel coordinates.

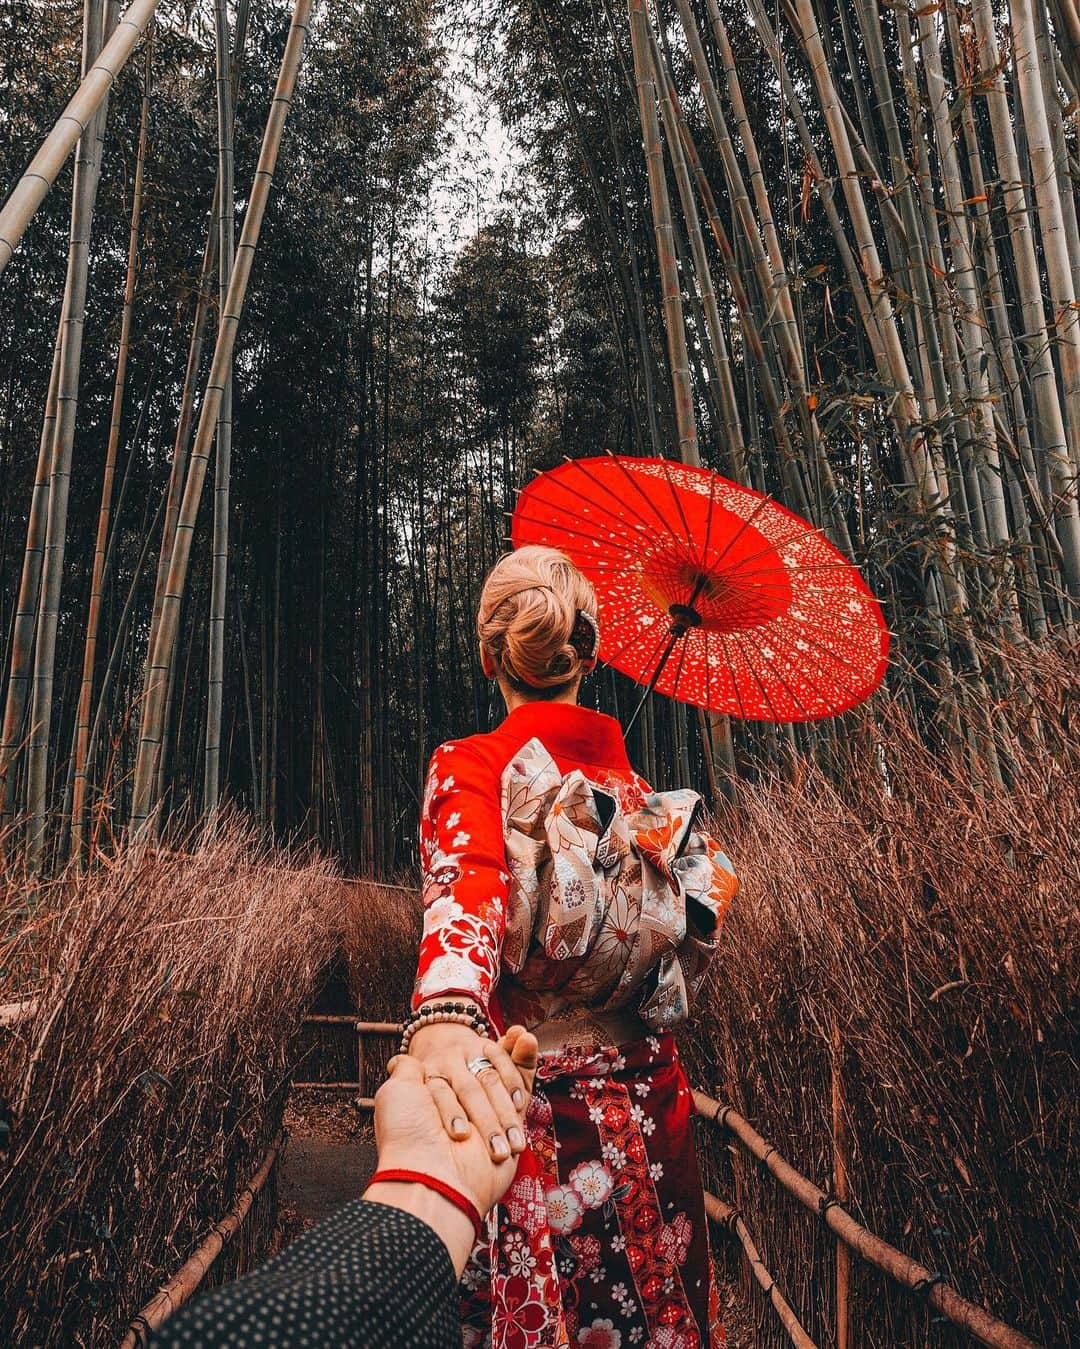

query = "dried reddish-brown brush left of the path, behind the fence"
[{"left": 0, "top": 828, "right": 345, "bottom": 1345}]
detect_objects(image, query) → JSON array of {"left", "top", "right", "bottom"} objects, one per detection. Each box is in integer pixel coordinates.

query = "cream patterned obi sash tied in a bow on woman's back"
[{"left": 502, "top": 739, "right": 738, "bottom": 1029}]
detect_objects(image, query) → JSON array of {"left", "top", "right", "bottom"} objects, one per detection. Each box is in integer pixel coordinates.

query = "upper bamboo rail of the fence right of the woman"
[{"left": 693, "top": 1091, "right": 1038, "bottom": 1349}]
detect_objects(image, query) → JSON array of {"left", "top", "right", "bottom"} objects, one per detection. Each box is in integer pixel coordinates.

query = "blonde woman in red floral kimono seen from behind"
[{"left": 407, "top": 548, "right": 736, "bottom": 1349}]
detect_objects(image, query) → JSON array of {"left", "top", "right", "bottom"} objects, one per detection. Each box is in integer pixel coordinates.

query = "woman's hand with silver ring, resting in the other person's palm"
[{"left": 409, "top": 1023, "right": 531, "bottom": 1161}]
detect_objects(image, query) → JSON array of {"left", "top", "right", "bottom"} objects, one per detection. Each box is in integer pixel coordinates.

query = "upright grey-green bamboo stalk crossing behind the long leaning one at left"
[{"left": 202, "top": 0, "right": 236, "bottom": 827}]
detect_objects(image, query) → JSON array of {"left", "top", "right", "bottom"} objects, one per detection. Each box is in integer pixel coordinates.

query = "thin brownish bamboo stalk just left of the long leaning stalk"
[{"left": 71, "top": 45, "right": 151, "bottom": 865}]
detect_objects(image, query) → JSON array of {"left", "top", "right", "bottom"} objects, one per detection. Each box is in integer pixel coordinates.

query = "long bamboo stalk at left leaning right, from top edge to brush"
[{"left": 131, "top": 0, "right": 311, "bottom": 834}]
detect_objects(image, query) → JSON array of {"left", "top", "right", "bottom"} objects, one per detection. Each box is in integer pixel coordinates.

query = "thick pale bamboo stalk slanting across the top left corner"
[{"left": 0, "top": 0, "right": 160, "bottom": 272}]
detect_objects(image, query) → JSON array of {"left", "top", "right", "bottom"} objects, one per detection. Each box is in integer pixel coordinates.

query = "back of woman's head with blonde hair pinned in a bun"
[{"left": 476, "top": 544, "right": 600, "bottom": 697}]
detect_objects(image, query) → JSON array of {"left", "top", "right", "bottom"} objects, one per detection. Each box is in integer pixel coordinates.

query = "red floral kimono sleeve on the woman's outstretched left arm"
[{"left": 413, "top": 741, "right": 510, "bottom": 1012}]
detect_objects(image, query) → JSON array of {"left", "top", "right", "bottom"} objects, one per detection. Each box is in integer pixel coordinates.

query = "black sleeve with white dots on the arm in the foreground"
[{"left": 151, "top": 1199, "right": 461, "bottom": 1349}]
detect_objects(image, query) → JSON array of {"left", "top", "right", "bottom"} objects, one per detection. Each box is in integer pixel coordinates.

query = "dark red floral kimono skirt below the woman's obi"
[{"left": 462, "top": 1035, "right": 725, "bottom": 1349}]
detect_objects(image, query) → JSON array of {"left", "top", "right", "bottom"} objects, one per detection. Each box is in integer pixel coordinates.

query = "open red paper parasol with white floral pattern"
[{"left": 511, "top": 455, "right": 889, "bottom": 722}]
